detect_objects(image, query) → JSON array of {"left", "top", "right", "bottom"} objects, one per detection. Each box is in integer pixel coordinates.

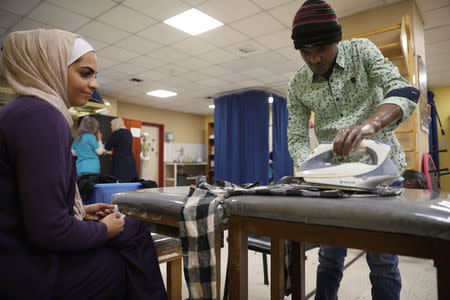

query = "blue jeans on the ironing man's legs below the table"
[{"left": 315, "top": 245, "right": 402, "bottom": 300}]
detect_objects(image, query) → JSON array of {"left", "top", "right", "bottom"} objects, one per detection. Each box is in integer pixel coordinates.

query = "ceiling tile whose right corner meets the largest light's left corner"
[{"left": 98, "top": 5, "right": 157, "bottom": 33}]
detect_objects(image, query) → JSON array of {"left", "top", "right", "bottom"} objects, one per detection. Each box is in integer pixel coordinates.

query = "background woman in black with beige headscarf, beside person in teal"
[{"left": 105, "top": 118, "right": 138, "bottom": 180}]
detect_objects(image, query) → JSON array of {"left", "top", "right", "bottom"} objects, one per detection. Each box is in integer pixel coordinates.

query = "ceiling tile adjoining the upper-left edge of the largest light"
[{"left": 122, "top": 0, "right": 191, "bottom": 21}]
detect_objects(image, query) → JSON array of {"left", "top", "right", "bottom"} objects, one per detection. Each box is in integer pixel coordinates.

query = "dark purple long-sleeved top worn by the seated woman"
[{"left": 0, "top": 96, "right": 107, "bottom": 288}]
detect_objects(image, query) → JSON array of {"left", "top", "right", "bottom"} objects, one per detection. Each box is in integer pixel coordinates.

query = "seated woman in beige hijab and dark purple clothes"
[{"left": 0, "top": 29, "right": 167, "bottom": 299}]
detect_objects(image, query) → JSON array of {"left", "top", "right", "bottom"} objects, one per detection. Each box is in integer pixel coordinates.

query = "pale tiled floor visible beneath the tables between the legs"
[{"left": 161, "top": 232, "right": 437, "bottom": 300}]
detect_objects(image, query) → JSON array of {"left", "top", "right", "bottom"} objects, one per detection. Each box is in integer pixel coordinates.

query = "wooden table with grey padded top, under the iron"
[{"left": 225, "top": 190, "right": 450, "bottom": 300}]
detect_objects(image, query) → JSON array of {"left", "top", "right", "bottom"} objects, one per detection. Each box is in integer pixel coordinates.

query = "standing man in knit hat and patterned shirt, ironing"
[{"left": 287, "top": 0, "right": 419, "bottom": 300}]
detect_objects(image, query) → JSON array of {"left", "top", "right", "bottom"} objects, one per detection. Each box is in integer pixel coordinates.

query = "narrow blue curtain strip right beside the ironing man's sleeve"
[{"left": 272, "top": 95, "right": 294, "bottom": 183}]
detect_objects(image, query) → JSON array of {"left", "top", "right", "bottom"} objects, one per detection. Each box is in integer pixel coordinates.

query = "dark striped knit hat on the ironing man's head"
[{"left": 291, "top": 0, "right": 342, "bottom": 49}]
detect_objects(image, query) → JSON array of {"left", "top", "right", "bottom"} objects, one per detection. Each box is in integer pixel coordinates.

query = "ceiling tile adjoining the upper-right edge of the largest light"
[{"left": 198, "top": 0, "right": 261, "bottom": 23}]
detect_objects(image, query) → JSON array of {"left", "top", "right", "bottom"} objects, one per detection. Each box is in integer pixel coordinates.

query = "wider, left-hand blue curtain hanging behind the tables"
[{"left": 214, "top": 91, "right": 269, "bottom": 185}]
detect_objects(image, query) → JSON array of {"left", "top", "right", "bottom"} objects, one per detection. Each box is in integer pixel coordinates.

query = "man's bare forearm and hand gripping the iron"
[{"left": 333, "top": 104, "right": 403, "bottom": 158}]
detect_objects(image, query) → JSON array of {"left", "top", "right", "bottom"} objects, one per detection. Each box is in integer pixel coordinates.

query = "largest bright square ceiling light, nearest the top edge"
[{"left": 164, "top": 8, "right": 223, "bottom": 35}]
